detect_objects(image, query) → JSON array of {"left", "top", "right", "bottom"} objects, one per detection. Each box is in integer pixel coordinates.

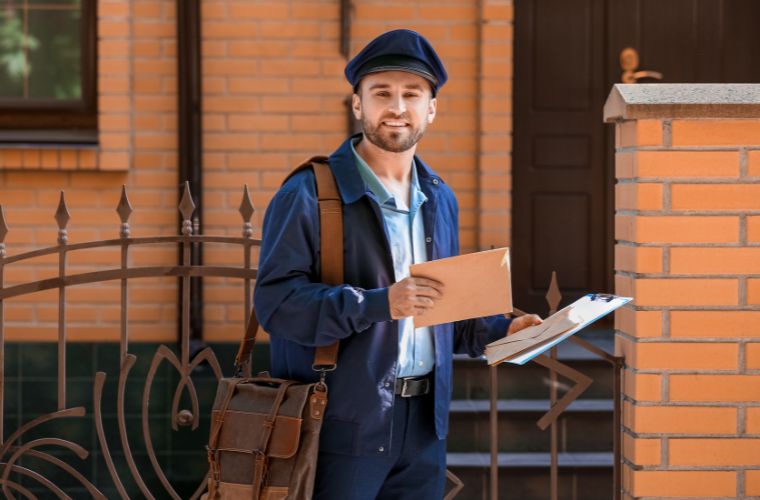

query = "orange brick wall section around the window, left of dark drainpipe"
[{"left": 0, "top": 0, "right": 178, "bottom": 341}]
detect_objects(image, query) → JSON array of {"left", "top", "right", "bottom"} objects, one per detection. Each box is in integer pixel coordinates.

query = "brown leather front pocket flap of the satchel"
[{"left": 212, "top": 410, "right": 302, "bottom": 458}]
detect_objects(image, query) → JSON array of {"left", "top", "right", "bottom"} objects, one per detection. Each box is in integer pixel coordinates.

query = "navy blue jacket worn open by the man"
[{"left": 254, "top": 139, "right": 509, "bottom": 456}]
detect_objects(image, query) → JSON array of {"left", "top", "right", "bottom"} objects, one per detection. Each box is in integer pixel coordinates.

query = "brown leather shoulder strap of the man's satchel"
[{"left": 235, "top": 156, "right": 343, "bottom": 375}]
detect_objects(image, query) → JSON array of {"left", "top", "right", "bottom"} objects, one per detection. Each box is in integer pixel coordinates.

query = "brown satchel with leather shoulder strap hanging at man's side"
[{"left": 201, "top": 157, "right": 343, "bottom": 500}]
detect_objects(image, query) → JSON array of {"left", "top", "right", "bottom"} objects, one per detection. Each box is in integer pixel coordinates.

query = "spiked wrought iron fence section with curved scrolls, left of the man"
[{"left": 0, "top": 183, "right": 462, "bottom": 500}]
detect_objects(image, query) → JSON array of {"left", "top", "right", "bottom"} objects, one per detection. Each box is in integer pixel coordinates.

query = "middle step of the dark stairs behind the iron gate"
[{"left": 448, "top": 399, "right": 613, "bottom": 452}]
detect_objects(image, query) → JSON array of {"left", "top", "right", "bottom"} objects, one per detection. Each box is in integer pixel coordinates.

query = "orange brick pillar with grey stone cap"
[{"left": 605, "top": 85, "right": 760, "bottom": 499}]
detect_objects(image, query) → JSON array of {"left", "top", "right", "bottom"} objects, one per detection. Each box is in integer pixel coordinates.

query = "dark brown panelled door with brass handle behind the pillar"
[{"left": 512, "top": 0, "right": 760, "bottom": 314}]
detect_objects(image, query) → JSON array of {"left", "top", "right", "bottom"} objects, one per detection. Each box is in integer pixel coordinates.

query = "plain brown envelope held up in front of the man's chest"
[{"left": 410, "top": 248, "right": 512, "bottom": 328}]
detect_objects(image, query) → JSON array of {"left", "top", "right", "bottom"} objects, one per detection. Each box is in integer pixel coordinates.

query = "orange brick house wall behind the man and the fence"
[{"left": 0, "top": 0, "right": 513, "bottom": 341}]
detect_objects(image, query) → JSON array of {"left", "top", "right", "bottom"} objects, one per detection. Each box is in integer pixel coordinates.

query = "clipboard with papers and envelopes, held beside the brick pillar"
[{"left": 486, "top": 293, "right": 632, "bottom": 365}]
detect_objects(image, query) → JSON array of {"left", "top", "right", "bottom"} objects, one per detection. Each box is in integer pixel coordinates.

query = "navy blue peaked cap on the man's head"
[{"left": 345, "top": 29, "right": 449, "bottom": 95}]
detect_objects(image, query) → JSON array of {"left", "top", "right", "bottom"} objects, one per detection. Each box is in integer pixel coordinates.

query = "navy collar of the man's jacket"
[{"left": 327, "top": 134, "right": 441, "bottom": 205}]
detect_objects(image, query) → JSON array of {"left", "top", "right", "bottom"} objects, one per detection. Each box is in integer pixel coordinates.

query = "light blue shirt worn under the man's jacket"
[{"left": 351, "top": 139, "right": 435, "bottom": 377}]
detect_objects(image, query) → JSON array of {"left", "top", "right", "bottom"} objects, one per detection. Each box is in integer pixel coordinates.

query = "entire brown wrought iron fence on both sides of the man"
[{"left": 0, "top": 185, "right": 621, "bottom": 500}]
